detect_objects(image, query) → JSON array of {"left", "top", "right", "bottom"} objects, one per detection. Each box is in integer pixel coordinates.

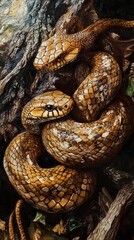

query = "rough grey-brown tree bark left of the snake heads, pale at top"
[{"left": 0, "top": 0, "right": 84, "bottom": 139}]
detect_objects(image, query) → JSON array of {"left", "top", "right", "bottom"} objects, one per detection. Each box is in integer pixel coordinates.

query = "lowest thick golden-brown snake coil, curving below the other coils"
[{"left": 4, "top": 133, "right": 95, "bottom": 212}]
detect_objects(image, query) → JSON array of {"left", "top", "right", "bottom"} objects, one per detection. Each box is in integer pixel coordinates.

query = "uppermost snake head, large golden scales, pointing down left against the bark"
[{"left": 34, "top": 33, "right": 81, "bottom": 72}]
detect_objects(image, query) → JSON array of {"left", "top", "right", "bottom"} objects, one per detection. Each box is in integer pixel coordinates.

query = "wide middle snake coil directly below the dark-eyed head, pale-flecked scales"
[{"left": 42, "top": 98, "right": 132, "bottom": 167}]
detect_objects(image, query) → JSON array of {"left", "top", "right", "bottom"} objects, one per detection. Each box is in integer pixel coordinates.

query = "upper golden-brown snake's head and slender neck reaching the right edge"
[{"left": 34, "top": 19, "right": 134, "bottom": 72}]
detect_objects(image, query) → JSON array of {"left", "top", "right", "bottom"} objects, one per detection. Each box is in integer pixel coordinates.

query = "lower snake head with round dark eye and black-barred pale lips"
[{"left": 21, "top": 90, "right": 74, "bottom": 134}]
